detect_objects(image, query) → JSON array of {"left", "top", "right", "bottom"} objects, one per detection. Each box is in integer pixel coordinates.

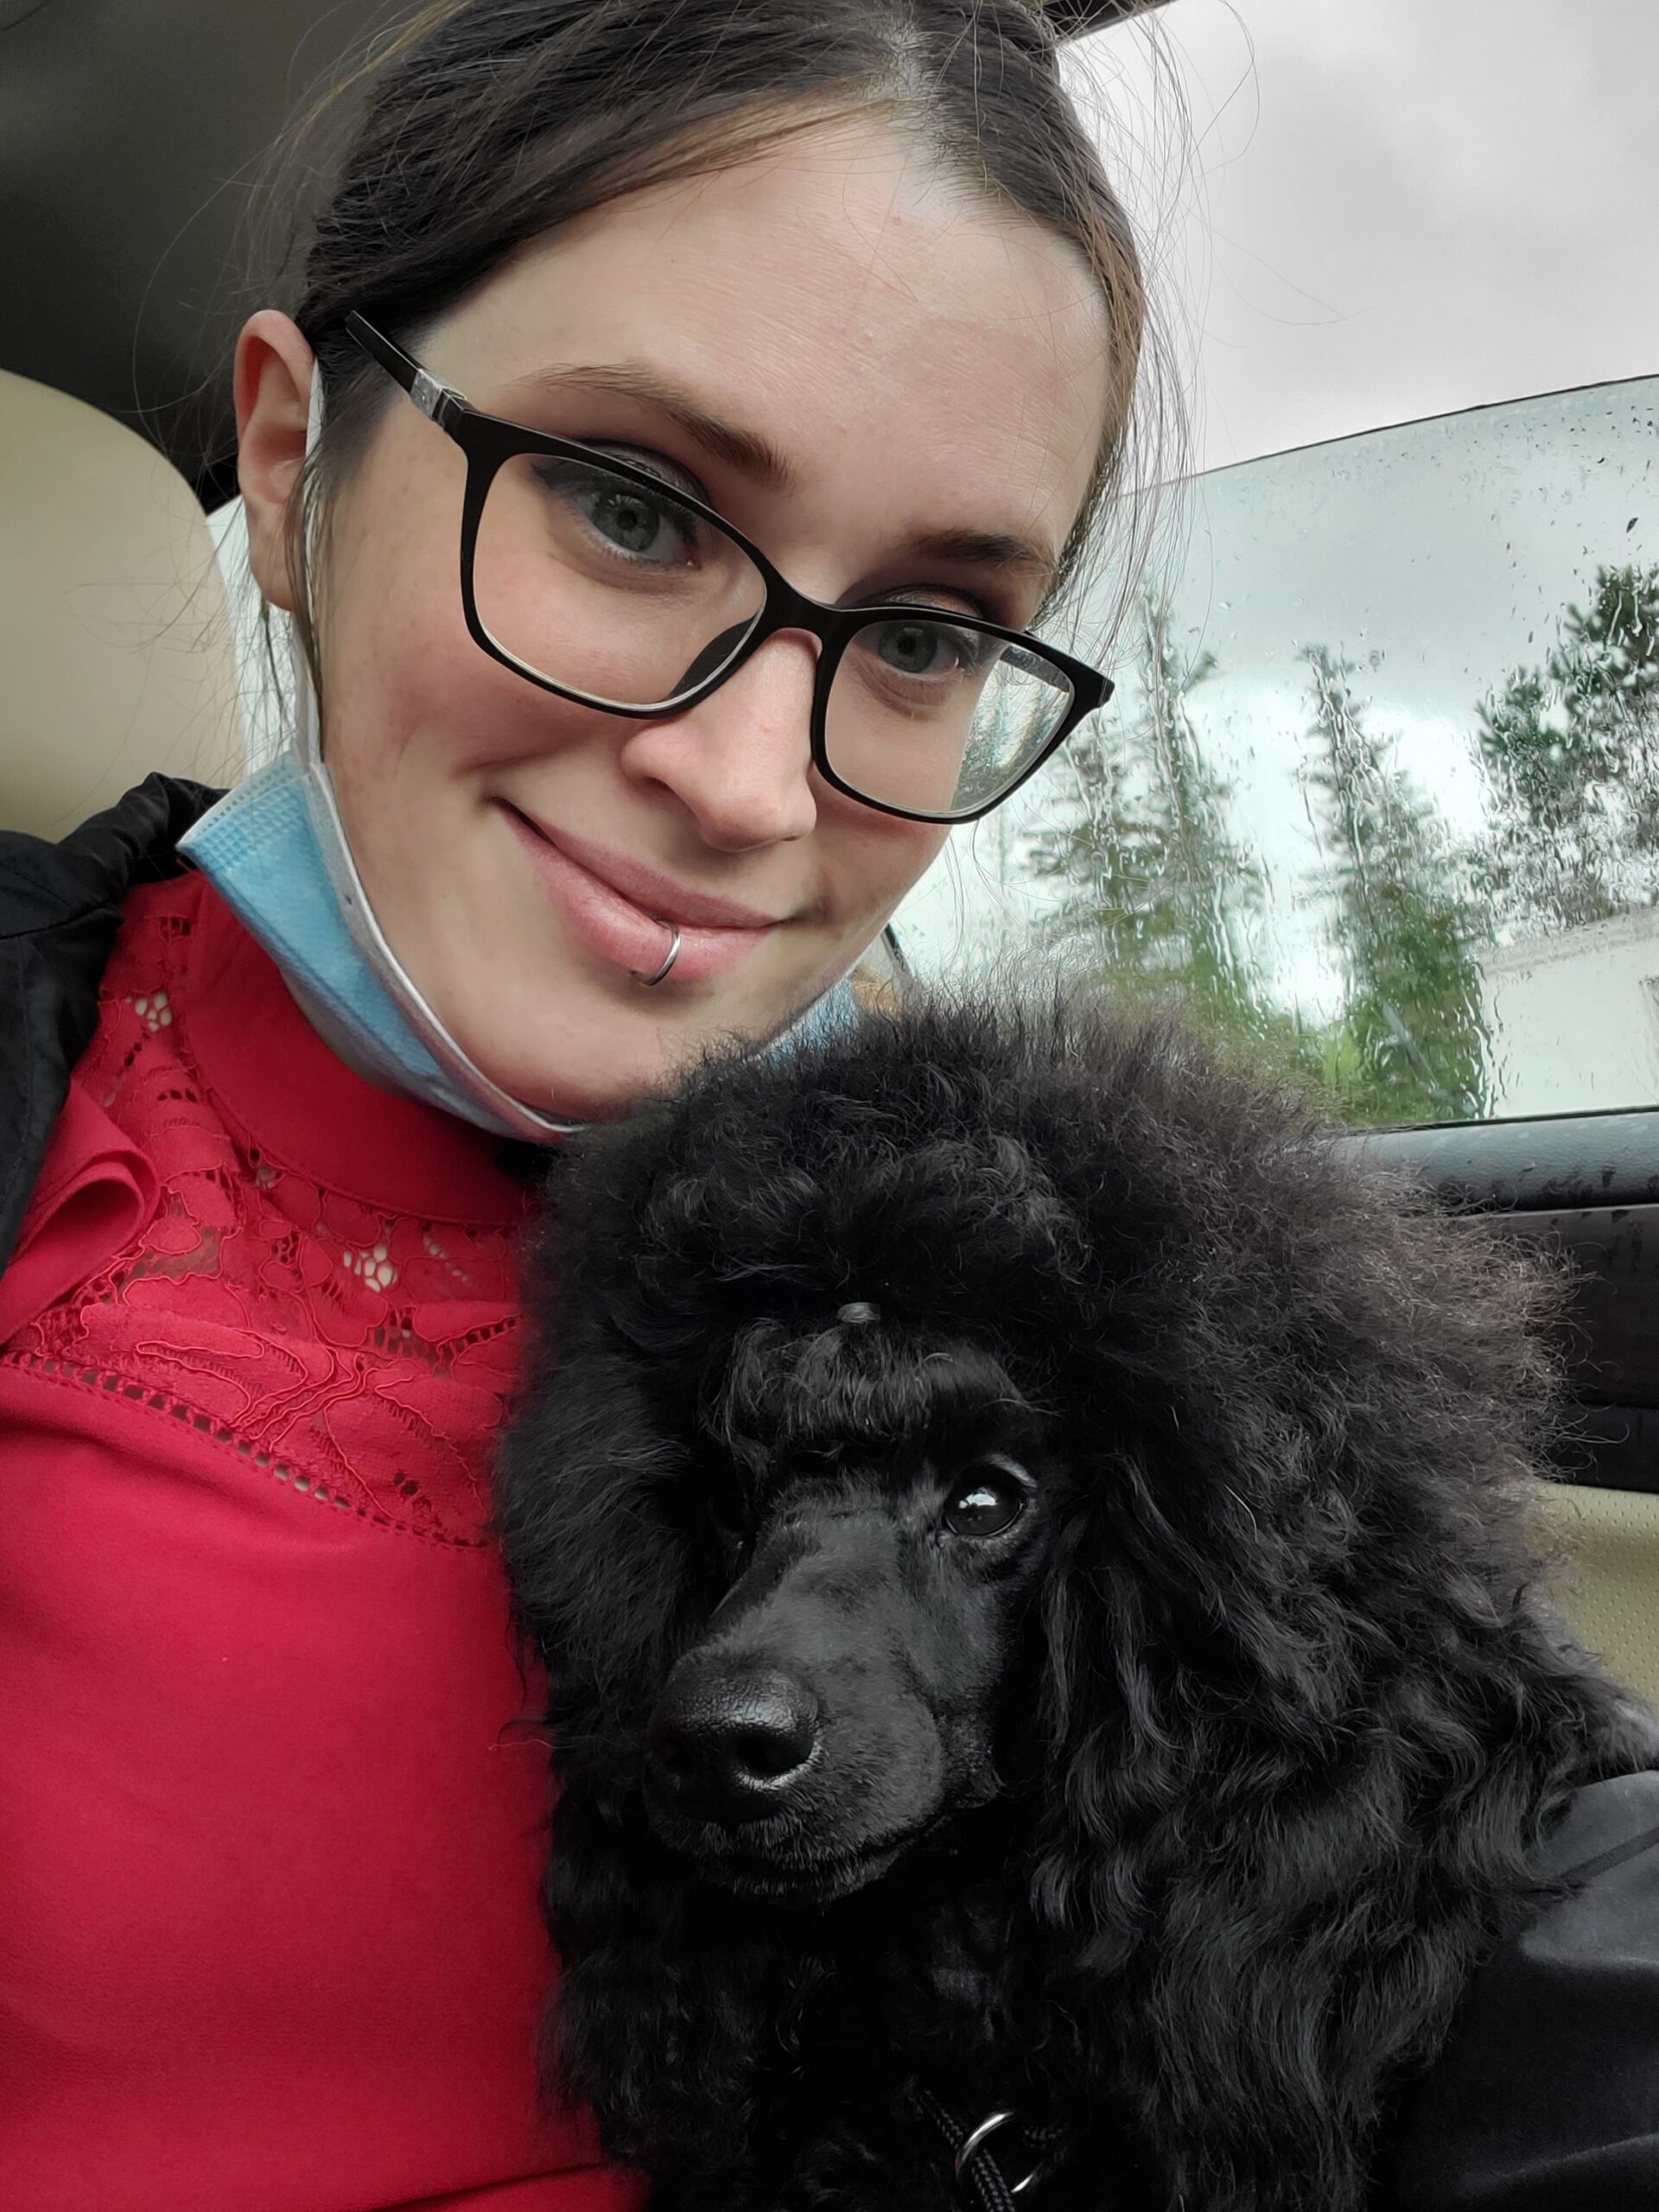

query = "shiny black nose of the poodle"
[{"left": 646, "top": 1668, "right": 818, "bottom": 1825}]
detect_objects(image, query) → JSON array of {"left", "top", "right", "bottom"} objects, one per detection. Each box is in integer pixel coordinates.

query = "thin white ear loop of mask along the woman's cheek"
[{"left": 288, "top": 360, "right": 588, "bottom": 1144}]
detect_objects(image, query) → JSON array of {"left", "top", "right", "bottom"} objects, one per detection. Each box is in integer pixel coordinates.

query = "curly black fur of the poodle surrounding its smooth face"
[{"left": 500, "top": 998, "right": 1652, "bottom": 2212}]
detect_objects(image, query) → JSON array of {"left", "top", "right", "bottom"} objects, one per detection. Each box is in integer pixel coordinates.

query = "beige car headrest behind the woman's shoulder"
[{"left": 0, "top": 370, "right": 244, "bottom": 836}]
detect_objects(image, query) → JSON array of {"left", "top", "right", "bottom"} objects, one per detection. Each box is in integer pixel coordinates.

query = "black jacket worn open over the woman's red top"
[{"left": 0, "top": 777, "right": 1659, "bottom": 2212}]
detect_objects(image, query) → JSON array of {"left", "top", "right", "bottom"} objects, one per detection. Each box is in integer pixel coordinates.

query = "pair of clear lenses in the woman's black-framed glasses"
[{"left": 474, "top": 454, "right": 1073, "bottom": 814}]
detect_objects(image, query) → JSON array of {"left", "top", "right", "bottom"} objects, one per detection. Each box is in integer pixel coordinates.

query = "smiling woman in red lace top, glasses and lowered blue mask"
[{"left": 0, "top": 0, "right": 1141, "bottom": 2212}]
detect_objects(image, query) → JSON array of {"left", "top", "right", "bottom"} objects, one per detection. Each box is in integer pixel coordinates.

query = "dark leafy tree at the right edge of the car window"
[{"left": 1476, "top": 564, "right": 1659, "bottom": 933}]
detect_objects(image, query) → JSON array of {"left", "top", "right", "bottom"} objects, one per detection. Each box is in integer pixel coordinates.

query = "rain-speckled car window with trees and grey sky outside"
[{"left": 898, "top": 378, "right": 1659, "bottom": 1123}]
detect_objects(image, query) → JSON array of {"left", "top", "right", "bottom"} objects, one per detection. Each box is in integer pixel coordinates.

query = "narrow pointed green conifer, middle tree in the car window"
[{"left": 1303, "top": 646, "right": 1489, "bottom": 1123}]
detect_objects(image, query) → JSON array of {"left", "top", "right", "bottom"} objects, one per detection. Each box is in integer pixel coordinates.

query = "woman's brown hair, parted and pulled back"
[{"left": 253, "top": 0, "right": 1168, "bottom": 671}]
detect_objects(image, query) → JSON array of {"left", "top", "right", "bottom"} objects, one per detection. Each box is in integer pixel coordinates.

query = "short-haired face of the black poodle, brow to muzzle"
[{"left": 644, "top": 1300, "right": 1062, "bottom": 1903}]
